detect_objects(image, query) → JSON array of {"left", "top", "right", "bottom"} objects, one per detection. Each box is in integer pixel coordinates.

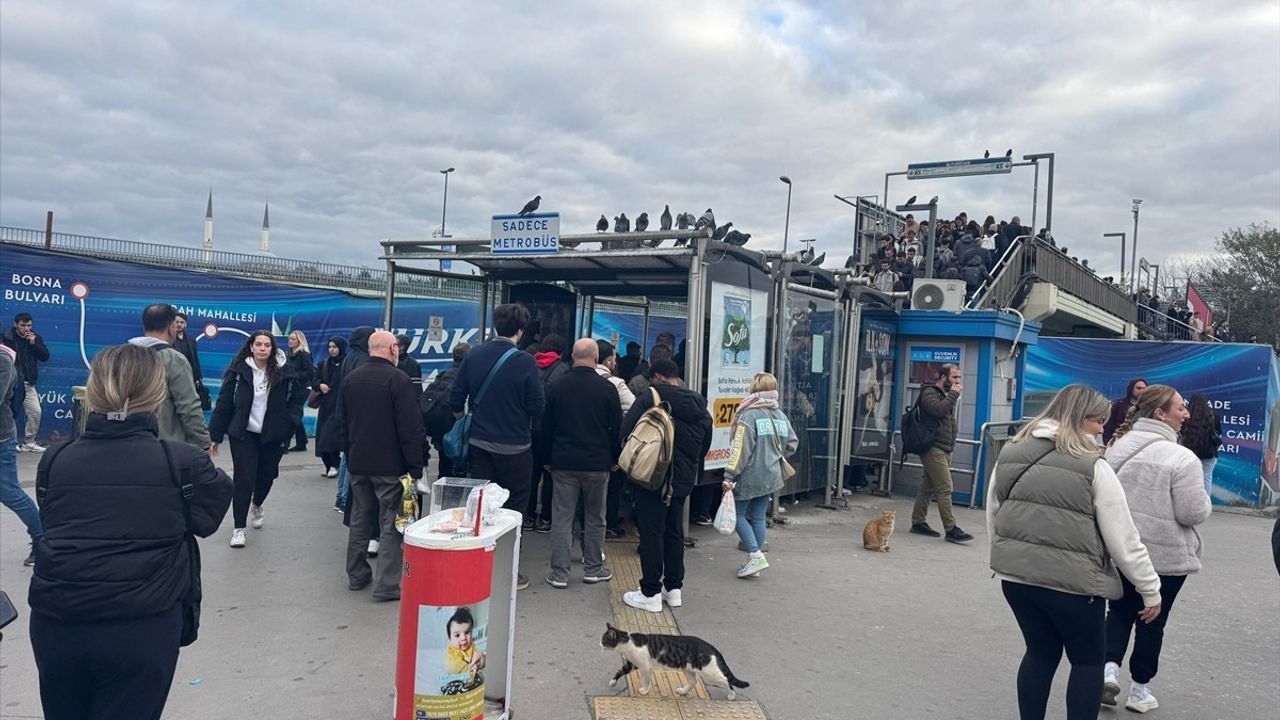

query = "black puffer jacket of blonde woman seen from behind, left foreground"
[{"left": 28, "top": 413, "right": 232, "bottom": 623}]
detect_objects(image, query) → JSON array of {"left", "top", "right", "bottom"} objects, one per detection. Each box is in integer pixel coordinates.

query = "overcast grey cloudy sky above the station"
[{"left": 0, "top": 0, "right": 1280, "bottom": 272}]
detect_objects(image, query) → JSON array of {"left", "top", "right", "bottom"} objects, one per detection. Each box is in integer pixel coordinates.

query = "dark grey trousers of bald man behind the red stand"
[{"left": 347, "top": 474, "right": 404, "bottom": 597}]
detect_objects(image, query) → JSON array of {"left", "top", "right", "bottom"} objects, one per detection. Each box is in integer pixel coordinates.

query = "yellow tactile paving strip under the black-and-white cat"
[{"left": 594, "top": 541, "right": 767, "bottom": 720}]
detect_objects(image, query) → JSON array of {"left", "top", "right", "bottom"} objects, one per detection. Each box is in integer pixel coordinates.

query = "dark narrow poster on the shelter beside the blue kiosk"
[{"left": 854, "top": 311, "right": 897, "bottom": 462}]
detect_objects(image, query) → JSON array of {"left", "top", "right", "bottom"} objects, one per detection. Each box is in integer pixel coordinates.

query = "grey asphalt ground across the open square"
[{"left": 0, "top": 445, "right": 1280, "bottom": 720}]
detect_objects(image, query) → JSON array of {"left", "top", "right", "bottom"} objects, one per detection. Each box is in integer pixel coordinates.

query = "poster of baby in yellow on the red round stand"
[{"left": 413, "top": 601, "right": 489, "bottom": 720}]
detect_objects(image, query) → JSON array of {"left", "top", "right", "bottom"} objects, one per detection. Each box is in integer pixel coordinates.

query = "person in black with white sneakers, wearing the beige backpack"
[{"left": 621, "top": 360, "right": 712, "bottom": 612}]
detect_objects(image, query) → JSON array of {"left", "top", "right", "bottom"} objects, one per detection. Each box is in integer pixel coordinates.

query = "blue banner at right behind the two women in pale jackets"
[{"left": 1023, "top": 338, "right": 1280, "bottom": 506}]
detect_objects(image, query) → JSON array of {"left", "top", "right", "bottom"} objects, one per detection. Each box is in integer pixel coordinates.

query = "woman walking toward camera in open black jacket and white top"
[{"left": 209, "top": 331, "right": 306, "bottom": 547}]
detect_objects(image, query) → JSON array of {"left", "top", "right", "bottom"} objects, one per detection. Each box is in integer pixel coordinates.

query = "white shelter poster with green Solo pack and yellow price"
[{"left": 707, "top": 282, "right": 769, "bottom": 470}]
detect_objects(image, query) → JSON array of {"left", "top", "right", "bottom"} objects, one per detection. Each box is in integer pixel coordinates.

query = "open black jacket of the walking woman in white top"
[{"left": 209, "top": 351, "right": 307, "bottom": 443}]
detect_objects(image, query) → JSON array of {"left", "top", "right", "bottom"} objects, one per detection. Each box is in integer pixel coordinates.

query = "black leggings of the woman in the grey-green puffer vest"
[{"left": 1001, "top": 580, "right": 1107, "bottom": 720}]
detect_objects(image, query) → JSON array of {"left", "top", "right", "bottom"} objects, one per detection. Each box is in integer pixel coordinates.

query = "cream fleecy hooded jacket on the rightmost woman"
[{"left": 1106, "top": 418, "right": 1213, "bottom": 575}]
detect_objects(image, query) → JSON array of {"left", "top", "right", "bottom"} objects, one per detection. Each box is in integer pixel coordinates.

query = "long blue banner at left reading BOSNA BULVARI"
[{"left": 0, "top": 245, "right": 480, "bottom": 439}]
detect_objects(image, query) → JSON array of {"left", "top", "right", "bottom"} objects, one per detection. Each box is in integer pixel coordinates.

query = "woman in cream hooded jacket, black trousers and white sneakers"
[{"left": 1103, "top": 384, "right": 1213, "bottom": 712}]
